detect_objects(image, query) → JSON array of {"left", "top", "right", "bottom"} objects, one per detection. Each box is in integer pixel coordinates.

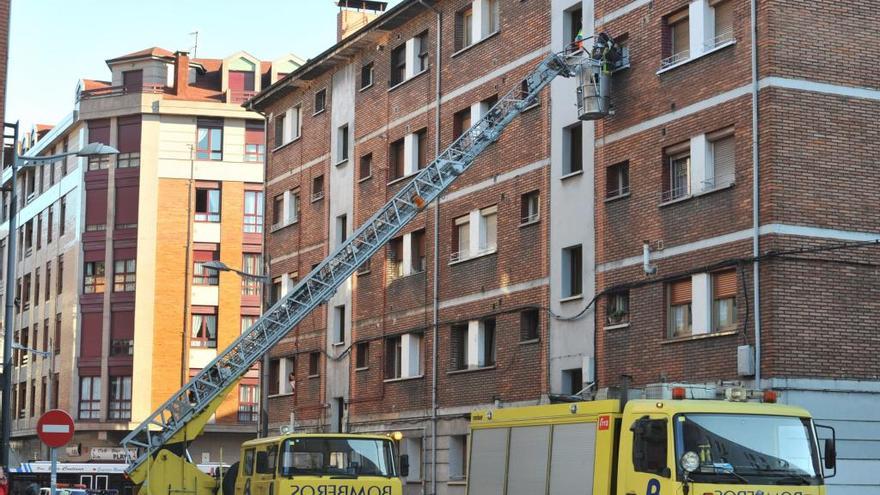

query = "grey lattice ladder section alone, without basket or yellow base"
[{"left": 122, "top": 51, "right": 596, "bottom": 473}]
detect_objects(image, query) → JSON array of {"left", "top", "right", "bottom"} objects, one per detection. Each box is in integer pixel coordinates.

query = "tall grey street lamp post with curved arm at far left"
[{"left": 0, "top": 122, "right": 119, "bottom": 468}]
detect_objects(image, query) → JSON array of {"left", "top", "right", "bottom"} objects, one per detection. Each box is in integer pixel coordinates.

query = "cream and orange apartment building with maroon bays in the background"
[{"left": 0, "top": 48, "right": 302, "bottom": 488}]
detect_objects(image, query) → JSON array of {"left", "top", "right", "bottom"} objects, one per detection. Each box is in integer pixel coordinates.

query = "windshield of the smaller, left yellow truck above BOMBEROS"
[{"left": 281, "top": 437, "right": 395, "bottom": 477}]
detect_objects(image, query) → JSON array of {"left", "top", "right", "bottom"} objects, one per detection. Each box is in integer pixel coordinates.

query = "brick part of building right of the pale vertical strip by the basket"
[{"left": 584, "top": 0, "right": 880, "bottom": 494}]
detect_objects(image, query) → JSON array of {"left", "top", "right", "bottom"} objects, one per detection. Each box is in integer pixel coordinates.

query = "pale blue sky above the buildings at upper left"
[{"left": 6, "top": 0, "right": 401, "bottom": 129}]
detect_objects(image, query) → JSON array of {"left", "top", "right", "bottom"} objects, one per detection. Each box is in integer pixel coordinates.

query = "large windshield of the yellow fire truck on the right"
[{"left": 675, "top": 414, "right": 820, "bottom": 485}]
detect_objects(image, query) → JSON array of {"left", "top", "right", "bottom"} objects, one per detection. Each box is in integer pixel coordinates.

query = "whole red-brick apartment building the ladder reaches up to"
[{"left": 250, "top": 0, "right": 880, "bottom": 494}]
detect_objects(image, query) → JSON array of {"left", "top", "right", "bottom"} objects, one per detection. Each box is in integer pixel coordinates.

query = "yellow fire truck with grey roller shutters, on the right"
[{"left": 467, "top": 388, "right": 835, "bottom": 495}]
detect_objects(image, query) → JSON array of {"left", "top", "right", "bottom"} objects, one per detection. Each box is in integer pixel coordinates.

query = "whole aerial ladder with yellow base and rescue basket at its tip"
[{"left": 121, "top": 36, "right": 619, "bottom": 495}]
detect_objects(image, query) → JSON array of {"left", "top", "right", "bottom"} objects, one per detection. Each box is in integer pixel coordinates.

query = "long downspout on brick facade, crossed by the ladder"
[{"left": 418, "top": 0, "right": 443, "bottom": 495}]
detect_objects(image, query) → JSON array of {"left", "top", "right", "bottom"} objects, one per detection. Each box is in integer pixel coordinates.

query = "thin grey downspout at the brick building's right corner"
[{"left": 749, "top": 0, "right": 761, "bottom": 388}]
